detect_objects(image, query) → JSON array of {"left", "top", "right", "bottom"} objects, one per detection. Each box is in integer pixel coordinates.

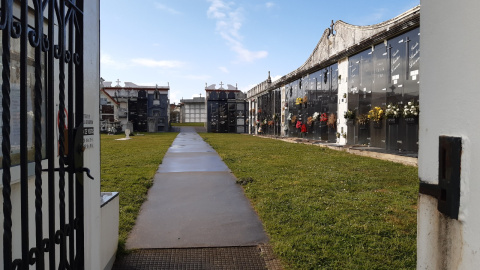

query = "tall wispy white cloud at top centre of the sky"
[{"left": 207, "top": 0, "right": 268, "bottom": 62}]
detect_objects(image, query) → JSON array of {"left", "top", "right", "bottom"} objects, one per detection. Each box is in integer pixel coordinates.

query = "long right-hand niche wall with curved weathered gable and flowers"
[{"left": 247, "top": 6, "right": 420, "bottom": 153}]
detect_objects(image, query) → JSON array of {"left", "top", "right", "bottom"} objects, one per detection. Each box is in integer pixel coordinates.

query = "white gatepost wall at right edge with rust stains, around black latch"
[{"left": 417, "top": 0, "right": 480, "bottom": 269}]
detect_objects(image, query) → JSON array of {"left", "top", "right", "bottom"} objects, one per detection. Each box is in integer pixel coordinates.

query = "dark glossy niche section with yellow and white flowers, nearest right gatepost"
[{"left": 343, "top": 28, "right": 420, "bottom": 152}]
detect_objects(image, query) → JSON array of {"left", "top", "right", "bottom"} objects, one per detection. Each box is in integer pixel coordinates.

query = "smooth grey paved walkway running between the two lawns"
[{"left": 126, "top": 127, "right": 268, "bottom": 249}]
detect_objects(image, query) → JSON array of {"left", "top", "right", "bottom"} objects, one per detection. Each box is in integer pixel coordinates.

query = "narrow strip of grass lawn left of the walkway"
[{"left": 100, "top": 132, "right": 178, "bottom": 255}]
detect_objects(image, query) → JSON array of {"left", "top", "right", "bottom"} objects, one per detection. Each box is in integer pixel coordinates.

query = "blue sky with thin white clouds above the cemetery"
[{"left": 100, "top": 0, "right": 420, "bottom": 103}]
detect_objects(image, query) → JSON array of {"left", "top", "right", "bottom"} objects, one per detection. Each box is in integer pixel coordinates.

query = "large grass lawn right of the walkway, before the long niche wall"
[{"left": 201, "top": 133, "right": 418, "bottom": 270}]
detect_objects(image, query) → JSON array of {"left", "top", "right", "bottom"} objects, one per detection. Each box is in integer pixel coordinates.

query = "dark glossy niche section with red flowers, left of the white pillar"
[{"left": 284, "top": 64, "right": 338, "bottom": 142}]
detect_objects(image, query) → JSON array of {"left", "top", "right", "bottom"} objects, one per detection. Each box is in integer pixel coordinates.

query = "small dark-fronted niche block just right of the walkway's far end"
[{"left": 205, "top": 83, "right": 248, "bottom": 133}]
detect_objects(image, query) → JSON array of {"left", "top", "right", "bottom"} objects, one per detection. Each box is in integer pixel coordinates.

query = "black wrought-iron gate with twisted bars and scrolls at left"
[{"left": 0, "top": 0, "right": 88, "bottom": 269}]
